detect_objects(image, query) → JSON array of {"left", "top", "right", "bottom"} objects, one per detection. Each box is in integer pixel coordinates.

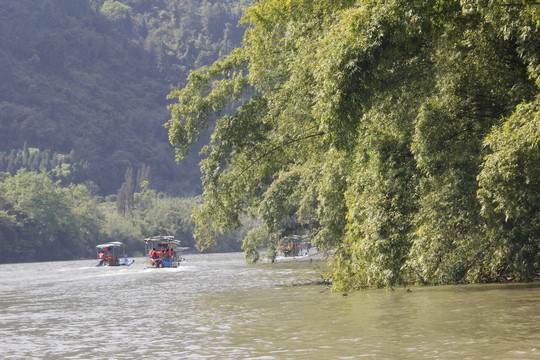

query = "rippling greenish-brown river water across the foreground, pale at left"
[{"left": 0, "top": 253, "right": 540, "bottom": 359}]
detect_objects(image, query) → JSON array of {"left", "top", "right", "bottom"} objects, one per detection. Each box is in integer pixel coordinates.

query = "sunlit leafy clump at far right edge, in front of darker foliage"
[{"left": 478, "top": 97, "right": 540, "bottom": 280}]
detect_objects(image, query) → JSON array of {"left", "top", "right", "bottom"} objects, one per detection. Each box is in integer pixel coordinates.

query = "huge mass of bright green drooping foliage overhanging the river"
[{"left": 168, "top": 0, "right": 540, "bottom": 289}]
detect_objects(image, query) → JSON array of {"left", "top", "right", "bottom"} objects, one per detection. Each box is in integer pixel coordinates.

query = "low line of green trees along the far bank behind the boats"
[{"left": 0, "top": 169, "right": 243, "bottom": 263}]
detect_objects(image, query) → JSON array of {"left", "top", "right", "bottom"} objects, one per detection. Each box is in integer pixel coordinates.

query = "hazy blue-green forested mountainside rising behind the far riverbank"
[{"left": 0, "top": 0, "right": 249, "bottom": 196}]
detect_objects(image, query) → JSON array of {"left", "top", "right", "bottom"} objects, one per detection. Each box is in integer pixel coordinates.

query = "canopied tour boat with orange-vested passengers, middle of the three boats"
[{"left": 144, "top": 235, "right": 184, "bottom": 268}]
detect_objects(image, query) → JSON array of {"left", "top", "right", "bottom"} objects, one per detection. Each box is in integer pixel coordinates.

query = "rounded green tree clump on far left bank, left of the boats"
[{"left": 0, "top": 170, "right": 102, "bottom": 262}]
